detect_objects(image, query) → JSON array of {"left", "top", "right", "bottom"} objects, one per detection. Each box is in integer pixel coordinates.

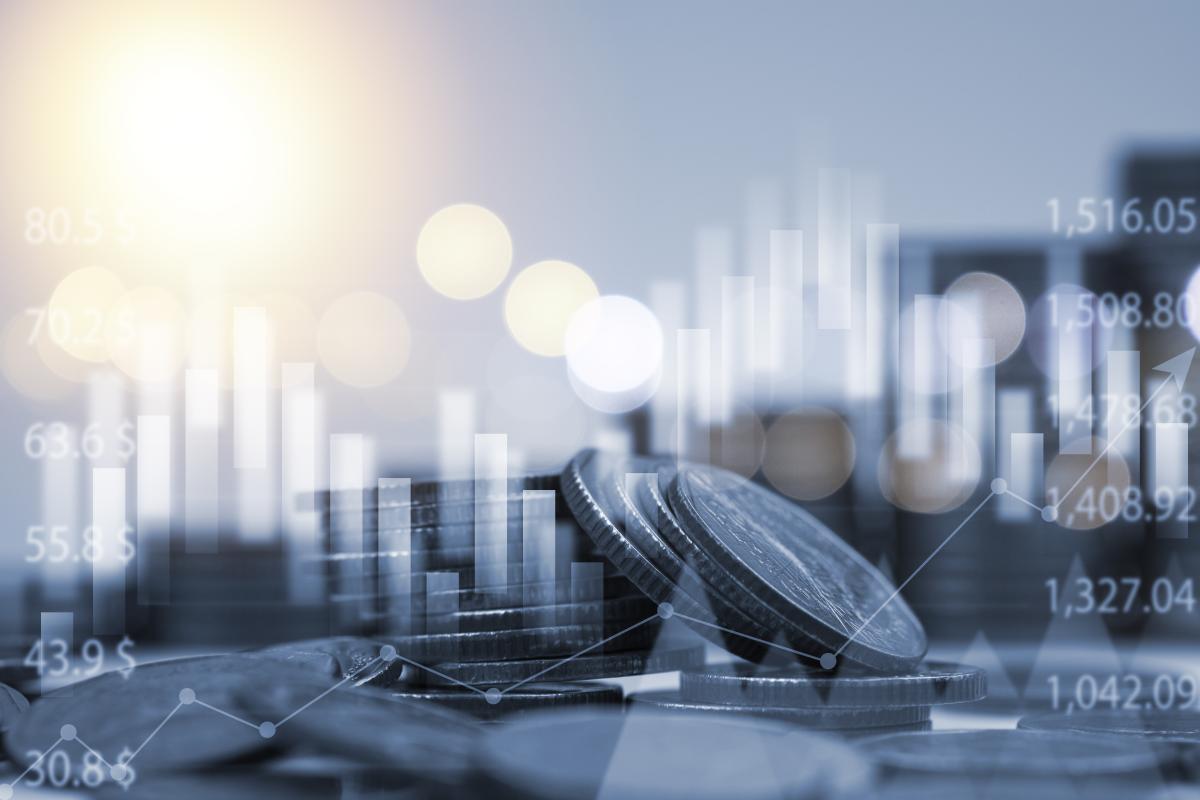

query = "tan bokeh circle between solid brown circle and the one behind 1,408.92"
[{"left": 878, "top": 419, "right": 980, "bottom": 513}]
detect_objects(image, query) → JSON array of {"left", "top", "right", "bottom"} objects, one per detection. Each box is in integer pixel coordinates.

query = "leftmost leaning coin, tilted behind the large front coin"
[{"left": 563, "top": 450, "right": 772, "bottom": 661}]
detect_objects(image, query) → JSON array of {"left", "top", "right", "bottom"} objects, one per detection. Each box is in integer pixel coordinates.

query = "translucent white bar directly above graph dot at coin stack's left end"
[{"left": 377, "top": 477, "right": 414, "bottom": 636}]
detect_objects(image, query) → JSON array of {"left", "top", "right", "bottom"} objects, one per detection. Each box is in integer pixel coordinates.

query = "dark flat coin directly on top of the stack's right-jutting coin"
[{"left": 390, "top": 625, "right": 658, "bottom": 662}]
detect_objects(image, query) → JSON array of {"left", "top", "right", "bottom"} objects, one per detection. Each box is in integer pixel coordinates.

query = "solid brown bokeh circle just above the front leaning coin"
[{"left": 762, "top": 408, "right": 854, "bottom": 500}]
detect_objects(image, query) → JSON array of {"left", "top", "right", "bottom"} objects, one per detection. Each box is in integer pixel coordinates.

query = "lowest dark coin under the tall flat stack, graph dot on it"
[{"left": 391, "top": 681, "right": 625, "bottom": 720}]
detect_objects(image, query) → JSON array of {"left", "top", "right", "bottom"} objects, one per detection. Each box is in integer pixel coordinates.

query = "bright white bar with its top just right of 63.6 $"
[{"left": 137, "top": 414, "right": 172, "bottom": 604}]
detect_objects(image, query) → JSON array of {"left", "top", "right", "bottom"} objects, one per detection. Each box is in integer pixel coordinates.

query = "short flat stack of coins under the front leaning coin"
[{"left": 630, "top": 662, "right": 988, "bottom": 736}]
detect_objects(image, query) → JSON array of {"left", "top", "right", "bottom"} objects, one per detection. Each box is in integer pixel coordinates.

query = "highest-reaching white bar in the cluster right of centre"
[{"left": 817, "top": 169, "right": 853, "bottom": 331}]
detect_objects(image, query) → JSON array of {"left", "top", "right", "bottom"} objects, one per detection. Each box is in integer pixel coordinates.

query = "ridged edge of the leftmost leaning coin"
[{"left": 562, "top": 449, "right": 770, "bottom": 661}]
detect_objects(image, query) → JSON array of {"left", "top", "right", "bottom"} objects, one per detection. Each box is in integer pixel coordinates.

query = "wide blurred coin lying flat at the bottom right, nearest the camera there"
[{"left": 859, "top": 730, "right": 1158, "bottom": 776}]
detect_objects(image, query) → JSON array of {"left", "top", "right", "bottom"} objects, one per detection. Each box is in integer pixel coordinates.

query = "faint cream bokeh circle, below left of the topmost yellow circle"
[{"left": 317, "top": 291, "right": 412, "bottom": 389}]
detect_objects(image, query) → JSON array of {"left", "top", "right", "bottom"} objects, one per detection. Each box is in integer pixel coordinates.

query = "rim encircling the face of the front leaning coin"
[{"left": 667, "top": 465, "right": 929, "bottom": 669}]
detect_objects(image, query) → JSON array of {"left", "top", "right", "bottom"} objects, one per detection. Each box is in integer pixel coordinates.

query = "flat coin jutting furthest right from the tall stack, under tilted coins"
[{"left": 413, "top": 644, "right": 704, "bottom": 686}]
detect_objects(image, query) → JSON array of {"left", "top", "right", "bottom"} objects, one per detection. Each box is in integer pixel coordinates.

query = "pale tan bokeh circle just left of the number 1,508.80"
[{"left": 942, "top": 272, "right": 1025, "bottom": 367}]
